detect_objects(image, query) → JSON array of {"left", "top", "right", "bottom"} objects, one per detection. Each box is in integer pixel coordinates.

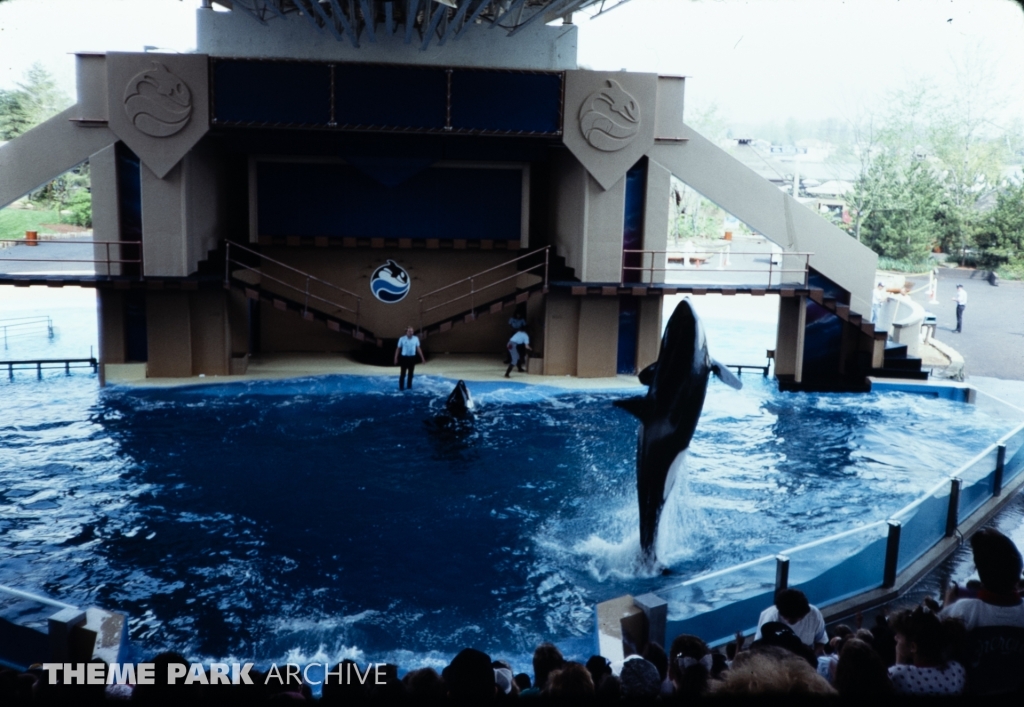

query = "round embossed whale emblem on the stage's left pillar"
[{"left": 125, "top": 61, "right": 193, "bottom": 137}]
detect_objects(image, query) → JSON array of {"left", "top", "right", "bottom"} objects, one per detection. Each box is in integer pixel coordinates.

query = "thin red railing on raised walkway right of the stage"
[{"left": 621, "top": 245, "right": 813, "bottom": 287}]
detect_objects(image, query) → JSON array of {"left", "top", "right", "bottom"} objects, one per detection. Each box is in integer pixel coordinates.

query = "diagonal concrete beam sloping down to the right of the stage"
[{"left": 647, "top": 125, "right": 878, "bottom": 314}]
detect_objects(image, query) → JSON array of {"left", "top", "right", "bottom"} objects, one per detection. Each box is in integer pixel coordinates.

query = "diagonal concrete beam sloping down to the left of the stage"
[{"left": 0, "top": 106, "right": 118, "bottom": 208}]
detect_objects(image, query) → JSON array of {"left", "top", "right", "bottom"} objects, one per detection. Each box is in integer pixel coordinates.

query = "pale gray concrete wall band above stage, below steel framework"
[{"left": 196, "top": 3, "right": 577, "bottom": 71}]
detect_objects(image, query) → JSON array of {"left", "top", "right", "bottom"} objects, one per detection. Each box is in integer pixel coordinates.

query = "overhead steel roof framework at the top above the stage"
[{"left": 210, "top": 0, "right": 629, "bottom": 49}]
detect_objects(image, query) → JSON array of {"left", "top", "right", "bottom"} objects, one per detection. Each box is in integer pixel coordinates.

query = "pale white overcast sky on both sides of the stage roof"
[{"left": 0, "top": 0, "right": 1024, "bottom": 128}]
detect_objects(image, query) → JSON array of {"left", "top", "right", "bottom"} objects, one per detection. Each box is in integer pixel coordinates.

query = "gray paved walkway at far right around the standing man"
[{"left": 909, "top": 268, "right": 1024, "bottom": 382}]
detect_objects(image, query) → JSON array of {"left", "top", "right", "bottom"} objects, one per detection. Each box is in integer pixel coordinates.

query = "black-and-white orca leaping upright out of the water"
[{"left": 614, "top": 299, "right": 743, "bottom": 567}]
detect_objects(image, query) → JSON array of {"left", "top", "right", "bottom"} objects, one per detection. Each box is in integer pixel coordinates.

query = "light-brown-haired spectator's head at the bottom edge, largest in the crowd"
[{"left": 712, "top": 646, "right": 836, "bottom": 696}]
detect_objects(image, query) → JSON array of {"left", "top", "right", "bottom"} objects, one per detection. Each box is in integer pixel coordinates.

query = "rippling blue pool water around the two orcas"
[{"left": 0, "top": 286, "right": 1008, "bottom": 669}]
